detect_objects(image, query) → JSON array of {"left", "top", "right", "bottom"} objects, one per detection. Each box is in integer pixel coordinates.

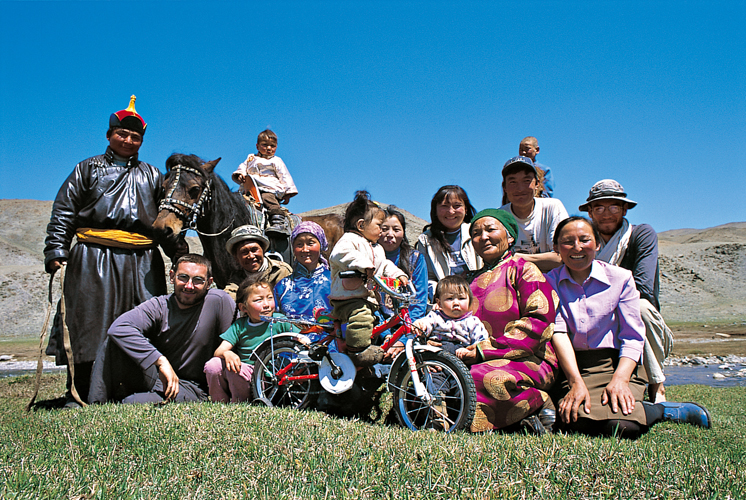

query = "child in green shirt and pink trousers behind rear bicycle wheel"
[{"left": 204, "top": 277, "right": 298, "bottom": 403}]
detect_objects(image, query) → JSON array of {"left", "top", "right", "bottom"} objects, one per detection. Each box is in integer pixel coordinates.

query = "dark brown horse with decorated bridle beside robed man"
[{"left": 153, "top": 153, "right": 344, "bottom": 288}]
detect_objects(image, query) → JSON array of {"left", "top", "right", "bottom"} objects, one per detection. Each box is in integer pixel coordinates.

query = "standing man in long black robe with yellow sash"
[{"left": 44, "top": 96, "right": 185, "bottom": 407}]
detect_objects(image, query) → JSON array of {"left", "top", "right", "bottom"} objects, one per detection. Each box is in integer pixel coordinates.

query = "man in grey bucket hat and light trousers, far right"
[{"left": 578, "top": 179, "right": 673, "bottom": 403}]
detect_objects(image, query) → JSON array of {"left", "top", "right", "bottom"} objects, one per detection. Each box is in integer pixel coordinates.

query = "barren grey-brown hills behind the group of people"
[{"left": 0, "top": 200, "right": 746, "bottom": 338}]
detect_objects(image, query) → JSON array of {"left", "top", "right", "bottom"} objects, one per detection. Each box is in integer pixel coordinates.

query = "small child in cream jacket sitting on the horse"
[{"left": 231, "top": 129, "right": 298, "bottom": 233}]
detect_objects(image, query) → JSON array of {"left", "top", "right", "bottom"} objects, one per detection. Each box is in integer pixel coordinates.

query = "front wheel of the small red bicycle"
[{"left": 389, "top": 351, "right": 477, "bottom": 432}]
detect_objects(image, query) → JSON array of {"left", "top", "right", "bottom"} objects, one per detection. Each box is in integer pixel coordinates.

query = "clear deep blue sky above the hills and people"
[{"left": 0, "top": 0, "right": 746, "bottom": 231}]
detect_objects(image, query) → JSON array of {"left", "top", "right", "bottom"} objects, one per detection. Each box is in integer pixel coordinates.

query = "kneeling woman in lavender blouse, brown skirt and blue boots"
[{"left": 546, "top": 217, "right": 711, "bottom": 438}]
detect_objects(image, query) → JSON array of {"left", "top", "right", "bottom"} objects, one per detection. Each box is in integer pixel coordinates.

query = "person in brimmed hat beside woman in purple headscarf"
[{"left": 225, "top": 225, "right": 293, "bottom": 300}]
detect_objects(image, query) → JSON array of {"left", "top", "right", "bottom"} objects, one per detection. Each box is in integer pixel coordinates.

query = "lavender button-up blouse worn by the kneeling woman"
[{"left": 546, "top": 260, "right": 645, "bottom": 362}]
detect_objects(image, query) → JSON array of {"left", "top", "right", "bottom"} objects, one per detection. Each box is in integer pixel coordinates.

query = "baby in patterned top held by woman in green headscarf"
[{"left": 413, "top": 275, "right": 489, "bottom": 359}]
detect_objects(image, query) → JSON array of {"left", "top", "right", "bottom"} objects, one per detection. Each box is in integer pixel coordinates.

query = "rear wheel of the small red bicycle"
[{"left": 251, "top": 340, "right": 321, "bottom": 410}]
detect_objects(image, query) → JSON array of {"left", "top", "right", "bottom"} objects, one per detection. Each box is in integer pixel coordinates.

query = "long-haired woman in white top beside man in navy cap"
[{"left": 417, "top": 185, "right": 482, "bottom": 299}]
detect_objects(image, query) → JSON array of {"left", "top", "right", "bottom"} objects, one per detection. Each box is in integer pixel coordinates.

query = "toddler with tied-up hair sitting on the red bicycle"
[{"left": 329, "top": 191, "right": 408, "bottom": 366}]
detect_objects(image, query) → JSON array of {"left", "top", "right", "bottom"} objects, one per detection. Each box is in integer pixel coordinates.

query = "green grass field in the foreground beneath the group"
[{"left": 0, "top": 375, "right": 746, "bottom": 500}]
